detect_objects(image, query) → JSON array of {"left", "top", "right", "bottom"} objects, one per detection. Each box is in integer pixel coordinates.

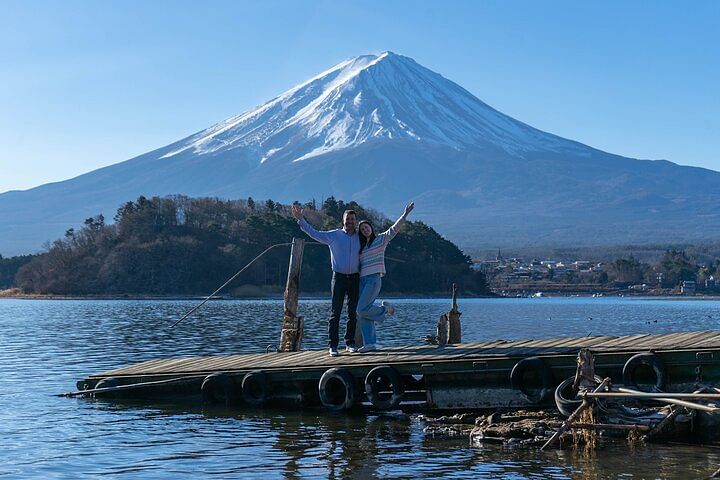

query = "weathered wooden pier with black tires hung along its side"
[{"left": 78, "top": 331, "right": 720, "bottom": 410}]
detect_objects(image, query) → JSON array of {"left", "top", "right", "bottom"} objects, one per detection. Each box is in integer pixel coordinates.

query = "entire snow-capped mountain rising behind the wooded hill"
[{"left": 0, "top": 52, "right": 720, "bottom": 255}]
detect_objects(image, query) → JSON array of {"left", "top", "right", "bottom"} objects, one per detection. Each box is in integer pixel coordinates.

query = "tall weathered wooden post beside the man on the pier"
[{"left": 279, "top": 238, "right": 305, "bottom": 352}]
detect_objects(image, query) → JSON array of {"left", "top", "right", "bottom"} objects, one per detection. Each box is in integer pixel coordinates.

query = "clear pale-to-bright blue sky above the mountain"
[{"left": 0, "top": 0, "right": 720, "bottom": 192}]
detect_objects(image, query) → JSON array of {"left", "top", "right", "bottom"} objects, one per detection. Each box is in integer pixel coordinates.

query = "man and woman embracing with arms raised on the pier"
[{"left": 292, "top": 202, "right": 415, "bottom": 357}]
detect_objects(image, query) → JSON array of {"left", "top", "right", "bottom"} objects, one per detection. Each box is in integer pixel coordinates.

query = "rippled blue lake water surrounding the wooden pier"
[{"left": 0, "top": 297, "right": 720, "bottom": 479}]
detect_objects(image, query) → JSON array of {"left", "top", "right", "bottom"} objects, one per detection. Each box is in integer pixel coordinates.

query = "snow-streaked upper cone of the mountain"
[{"left": 161, "top": 52, "right": 582, "bottom": 163}]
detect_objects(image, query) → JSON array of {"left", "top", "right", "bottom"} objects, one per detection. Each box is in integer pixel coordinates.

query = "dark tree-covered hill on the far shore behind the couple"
[{"left": 0, "top": 196, "right": 489, "bottom": 296}]
